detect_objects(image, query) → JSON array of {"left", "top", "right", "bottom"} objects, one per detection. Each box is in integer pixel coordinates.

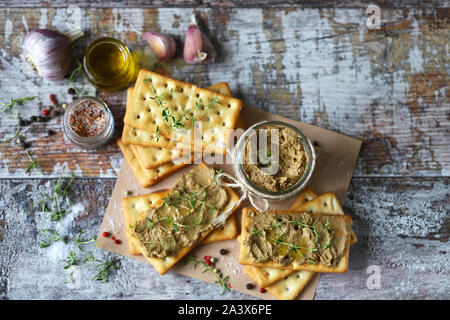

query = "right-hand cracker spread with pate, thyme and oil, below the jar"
[{"left": 239, "top": 208, "right": 351, "bottom": 272}]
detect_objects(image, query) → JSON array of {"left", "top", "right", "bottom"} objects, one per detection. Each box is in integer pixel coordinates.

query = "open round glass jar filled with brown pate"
[{"left": 233, "top": 121, "right": 316, "bottom": 200}]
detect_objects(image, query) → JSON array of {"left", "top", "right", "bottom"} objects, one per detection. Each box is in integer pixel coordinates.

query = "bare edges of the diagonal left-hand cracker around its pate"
[{"left": 130, "top": 163, "right": 239, "bottom": 274}]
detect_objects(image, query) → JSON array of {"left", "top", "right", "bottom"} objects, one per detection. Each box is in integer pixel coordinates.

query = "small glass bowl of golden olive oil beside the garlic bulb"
[{"left": 83, "top": 37, "right": 136, "bottom": 91}]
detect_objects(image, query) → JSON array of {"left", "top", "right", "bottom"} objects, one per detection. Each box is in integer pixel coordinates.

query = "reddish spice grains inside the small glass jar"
[{"left": 69, "top": 101, "right": 106, "bottom": 137}]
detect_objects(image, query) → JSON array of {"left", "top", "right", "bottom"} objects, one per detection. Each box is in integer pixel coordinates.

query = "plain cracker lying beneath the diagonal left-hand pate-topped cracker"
[{"left": 122, "top": 191, "right": 238, "bottom": 255}]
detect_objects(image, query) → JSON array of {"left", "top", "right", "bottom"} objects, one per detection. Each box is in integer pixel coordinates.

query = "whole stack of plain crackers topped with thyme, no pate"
[{"left": 117, "top": 69, "right": 242, "bottom": 187}]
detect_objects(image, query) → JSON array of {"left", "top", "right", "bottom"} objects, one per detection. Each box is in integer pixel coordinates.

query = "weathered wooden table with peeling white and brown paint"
[{"left": 0, "top": 0, "right": 450, "bottom": 299}]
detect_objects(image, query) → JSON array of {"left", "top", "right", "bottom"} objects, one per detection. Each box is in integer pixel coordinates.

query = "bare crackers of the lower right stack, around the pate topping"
[{"left": 238, "top": 189, "right": 357, "bottom": 300}]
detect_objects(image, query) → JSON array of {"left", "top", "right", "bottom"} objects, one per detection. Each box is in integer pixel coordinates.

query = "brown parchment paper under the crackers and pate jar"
[{"left": 97, "top": 107, "right": 361, "bottom": 300}]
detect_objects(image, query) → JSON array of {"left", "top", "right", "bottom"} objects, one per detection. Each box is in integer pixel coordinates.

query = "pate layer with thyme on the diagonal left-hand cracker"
[{"left": 132, "top": 165, "right": 229, "bottom": 258}]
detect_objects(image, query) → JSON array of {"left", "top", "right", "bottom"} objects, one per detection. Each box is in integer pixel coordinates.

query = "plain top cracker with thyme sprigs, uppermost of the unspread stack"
[{"left": 124, "top": 69, "right": 242, "bottom": 154}]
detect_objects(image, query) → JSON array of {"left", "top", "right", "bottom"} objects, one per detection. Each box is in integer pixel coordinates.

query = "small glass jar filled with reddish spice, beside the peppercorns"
[{"left": 63, "top": 97, "right": 114, "bottom": 149}]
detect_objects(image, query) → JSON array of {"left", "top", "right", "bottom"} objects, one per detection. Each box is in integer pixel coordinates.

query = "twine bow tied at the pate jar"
[{"left": 213, "top": 172, "right": 269, "bottom": 227}]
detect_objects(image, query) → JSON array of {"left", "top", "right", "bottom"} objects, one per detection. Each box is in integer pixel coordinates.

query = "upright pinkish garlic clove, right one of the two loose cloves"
[{"left": 183, "top": 15, "right": 215, "bottom": 64}]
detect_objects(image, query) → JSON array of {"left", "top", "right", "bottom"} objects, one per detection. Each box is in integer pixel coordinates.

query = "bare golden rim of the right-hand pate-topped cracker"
[{"left": 238, "top": 208, "right": 352, "bottom": 273}]
